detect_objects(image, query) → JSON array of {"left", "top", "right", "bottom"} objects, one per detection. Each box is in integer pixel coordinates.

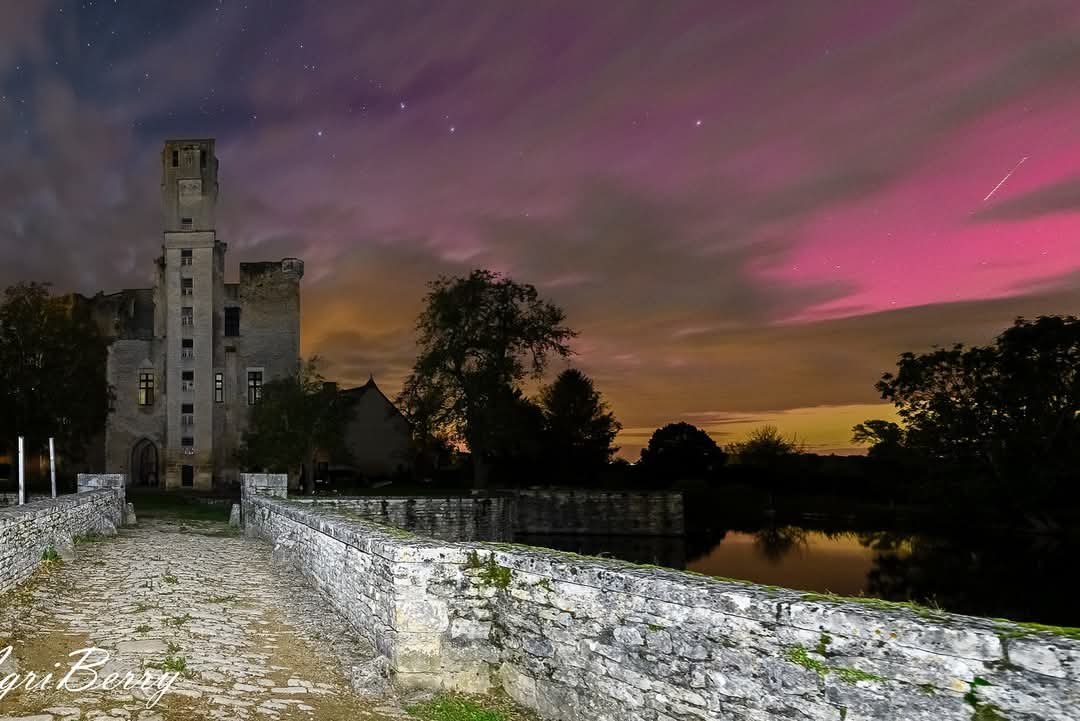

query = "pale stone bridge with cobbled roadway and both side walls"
[{"left": 0, "top": 475, "right": 1080, "bottom": 721}]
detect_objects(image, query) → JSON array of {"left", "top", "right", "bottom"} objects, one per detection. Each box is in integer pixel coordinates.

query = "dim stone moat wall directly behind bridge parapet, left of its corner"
[{"left": 293, "top": 495, "right": 514, "bottom": 541}]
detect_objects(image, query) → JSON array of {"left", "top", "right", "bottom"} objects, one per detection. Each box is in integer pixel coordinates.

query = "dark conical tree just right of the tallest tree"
[{"left": 540, "top": 368, "right": 622, "bottom": 476}]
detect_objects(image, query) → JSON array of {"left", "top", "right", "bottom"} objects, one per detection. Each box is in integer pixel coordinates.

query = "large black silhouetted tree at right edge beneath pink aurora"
[{"left": 877, "top": 316, "right": 1080, "bottom": 504}]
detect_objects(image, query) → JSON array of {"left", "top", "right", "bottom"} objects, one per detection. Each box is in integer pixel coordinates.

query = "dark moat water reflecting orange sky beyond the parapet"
[{"left": 517, "top": 526, "right": 1080, "bottom": 626}]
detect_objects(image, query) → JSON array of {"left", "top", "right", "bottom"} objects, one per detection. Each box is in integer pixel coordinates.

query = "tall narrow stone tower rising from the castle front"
[{"left": 158, "top": 139, "right": 226, "bottom": 488}]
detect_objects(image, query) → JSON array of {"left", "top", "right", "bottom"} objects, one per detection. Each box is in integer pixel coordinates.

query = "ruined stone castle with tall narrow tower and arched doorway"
[{"left": 92, "top": 139, "right": 303, "bottom": 489}]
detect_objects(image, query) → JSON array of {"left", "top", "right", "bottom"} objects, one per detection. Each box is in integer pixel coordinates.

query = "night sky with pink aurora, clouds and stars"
[{"left": 0, "top": 0, "right": 1080, "bottom": 458}]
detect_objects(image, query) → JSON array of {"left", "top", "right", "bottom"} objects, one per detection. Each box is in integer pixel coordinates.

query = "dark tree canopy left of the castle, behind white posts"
[{"left": 0, "top": 283, "right": 112, "bottom": 459}]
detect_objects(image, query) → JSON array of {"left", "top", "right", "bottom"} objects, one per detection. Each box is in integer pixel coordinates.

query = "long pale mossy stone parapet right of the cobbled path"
[{"left": 244, "top": 479, "right": 1080, "bottom": 721}]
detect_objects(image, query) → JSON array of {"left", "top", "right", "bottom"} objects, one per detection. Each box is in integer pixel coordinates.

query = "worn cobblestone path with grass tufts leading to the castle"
[{"left": 0, "top": 520, "right": 407, "bottom": 721}]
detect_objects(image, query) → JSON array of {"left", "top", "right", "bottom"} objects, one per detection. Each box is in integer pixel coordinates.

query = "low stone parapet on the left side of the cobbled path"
[{"left": 0, "top": 488, "right": 124, "bottom": 594}]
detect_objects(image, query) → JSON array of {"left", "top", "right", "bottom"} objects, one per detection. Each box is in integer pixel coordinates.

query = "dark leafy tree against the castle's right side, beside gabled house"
[{"left": 239, "top": 356, "right": 352, "bottom": 493}]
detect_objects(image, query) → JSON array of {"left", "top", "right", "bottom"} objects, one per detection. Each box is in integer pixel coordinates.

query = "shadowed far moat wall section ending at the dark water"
[{"left": 514, "top": 490, "right": 686, "bottom": 535}]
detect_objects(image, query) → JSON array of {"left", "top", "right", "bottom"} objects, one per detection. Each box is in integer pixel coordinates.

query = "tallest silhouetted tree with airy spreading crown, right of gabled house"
[{"left": 397, "top": 270, "right": 576, "bottom": 486}]
